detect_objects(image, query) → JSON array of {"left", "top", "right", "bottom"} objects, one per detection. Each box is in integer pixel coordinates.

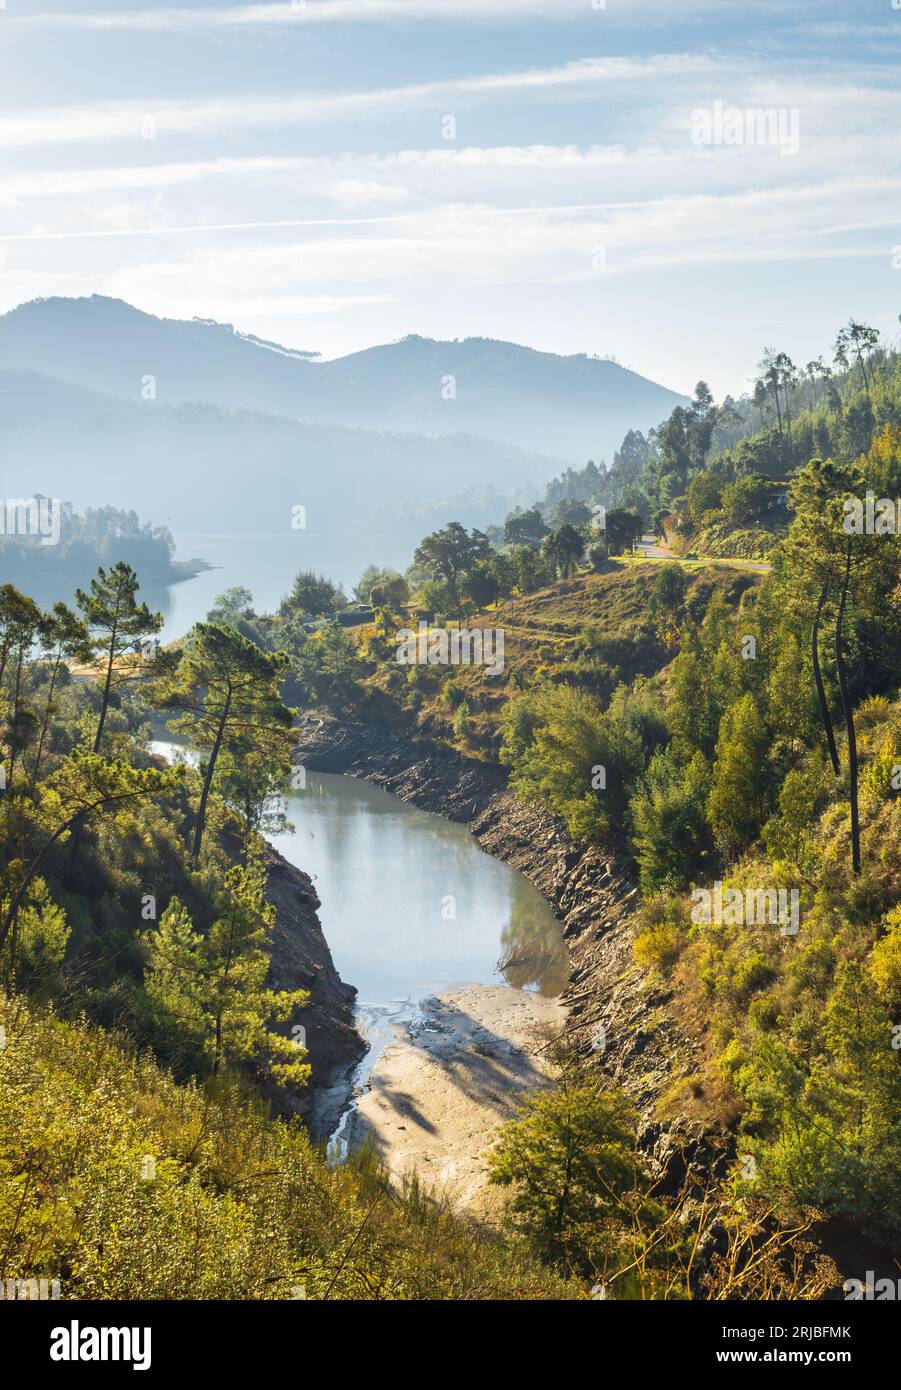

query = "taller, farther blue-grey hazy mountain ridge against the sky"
[{"left": 0, "top": 295, "right": 684, "bottom": 461}]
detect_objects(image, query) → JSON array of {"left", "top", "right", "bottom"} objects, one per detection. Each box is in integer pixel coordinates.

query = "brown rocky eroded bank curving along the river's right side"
[{"left": 300, "top": 721, "right": 724, "bottom": 1187}]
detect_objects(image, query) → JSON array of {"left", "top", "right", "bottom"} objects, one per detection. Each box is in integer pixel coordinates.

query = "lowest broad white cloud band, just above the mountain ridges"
[{"left": 10, "top": 177, "right": 901, "bottom": 279}]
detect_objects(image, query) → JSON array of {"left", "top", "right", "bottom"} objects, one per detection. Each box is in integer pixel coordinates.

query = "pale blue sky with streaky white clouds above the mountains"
[{"left": 0, "top": 0, "right": 901, "bottom": 398}]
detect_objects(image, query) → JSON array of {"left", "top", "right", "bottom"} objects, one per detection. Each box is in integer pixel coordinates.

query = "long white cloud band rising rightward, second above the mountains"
[{"left": 0, "top": 109, "right": 901, "bottom": 221}]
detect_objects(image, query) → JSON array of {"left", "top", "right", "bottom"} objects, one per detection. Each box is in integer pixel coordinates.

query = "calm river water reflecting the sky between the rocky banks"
[{"left": 153, "top": 741, "right": 570, "bottom": 1130}]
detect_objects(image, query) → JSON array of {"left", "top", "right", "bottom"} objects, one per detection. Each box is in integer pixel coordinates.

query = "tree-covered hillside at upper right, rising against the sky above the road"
[{"left": 508, "top": 320, "right": 901, "bottom": 557}]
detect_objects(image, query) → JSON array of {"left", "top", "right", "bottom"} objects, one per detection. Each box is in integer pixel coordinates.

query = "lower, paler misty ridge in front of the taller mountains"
[{"left": 0, "top": 370, "right": 556, "bottom": 547}]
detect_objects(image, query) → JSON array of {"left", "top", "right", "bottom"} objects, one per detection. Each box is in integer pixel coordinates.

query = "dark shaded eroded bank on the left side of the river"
[{"left": 267, "top": 847, "right": 366, "bottom": 1138}]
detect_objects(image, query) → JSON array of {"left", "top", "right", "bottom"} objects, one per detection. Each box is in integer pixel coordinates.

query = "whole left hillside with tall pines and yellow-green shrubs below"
[{"left": 0, "top": 562, "right": 581, "bottom": 1300}]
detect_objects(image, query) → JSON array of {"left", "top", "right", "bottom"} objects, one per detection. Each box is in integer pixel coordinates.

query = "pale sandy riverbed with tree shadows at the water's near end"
[{"left": 350, "top": 984, "right": 563, "bottom": 1215}]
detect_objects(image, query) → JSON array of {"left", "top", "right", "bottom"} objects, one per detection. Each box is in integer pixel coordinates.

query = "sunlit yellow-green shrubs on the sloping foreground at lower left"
[{"left": 0, "top": 994, "right": 581, "bottom": 1300}]
